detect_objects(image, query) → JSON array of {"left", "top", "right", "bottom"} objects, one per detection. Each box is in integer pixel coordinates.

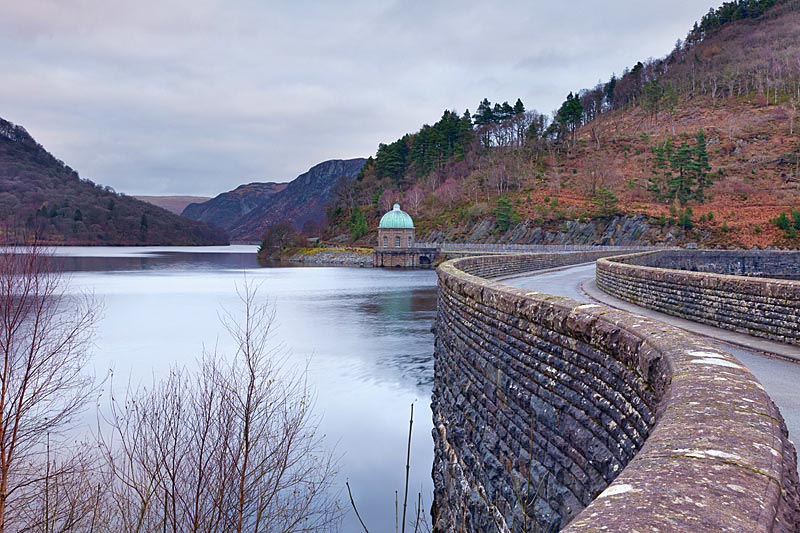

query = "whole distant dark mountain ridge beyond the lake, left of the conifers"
[{"left": 183, "top": 158, "right": 366, "bottom": 242}]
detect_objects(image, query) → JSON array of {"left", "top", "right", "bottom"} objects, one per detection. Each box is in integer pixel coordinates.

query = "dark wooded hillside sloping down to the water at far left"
[{"left": 0, "top": 119, "right": 228, "bottom": 245}]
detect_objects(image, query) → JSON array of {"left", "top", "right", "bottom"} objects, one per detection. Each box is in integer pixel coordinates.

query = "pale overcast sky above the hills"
[{"left": 0, "top": 0, "right": 719, "bottom": 196}]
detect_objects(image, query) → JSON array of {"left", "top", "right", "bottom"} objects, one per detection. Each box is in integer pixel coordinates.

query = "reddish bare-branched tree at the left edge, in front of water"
[{"left": 0, "top": 245, "right": 98, "bottom": 532}]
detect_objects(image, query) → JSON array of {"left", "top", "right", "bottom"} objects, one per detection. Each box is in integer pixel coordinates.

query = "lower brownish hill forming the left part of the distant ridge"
[{"left": 182, "top": 182, "right": 287, "bottom": 231}]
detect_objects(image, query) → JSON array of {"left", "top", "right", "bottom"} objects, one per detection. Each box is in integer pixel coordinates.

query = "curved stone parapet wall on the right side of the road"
[{"left": 596, "top": 250, "right": 800, "bottom": 345}]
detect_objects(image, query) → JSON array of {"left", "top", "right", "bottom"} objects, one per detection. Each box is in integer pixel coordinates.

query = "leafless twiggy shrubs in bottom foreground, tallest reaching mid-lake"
[{"left": 100, "top": 285, "right": 340, "bottom": 532}]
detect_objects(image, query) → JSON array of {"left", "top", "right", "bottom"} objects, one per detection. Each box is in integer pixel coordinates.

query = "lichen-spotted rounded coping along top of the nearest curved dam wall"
[{"left": 438, "top": 254, "right": 800, "bottom": 532}]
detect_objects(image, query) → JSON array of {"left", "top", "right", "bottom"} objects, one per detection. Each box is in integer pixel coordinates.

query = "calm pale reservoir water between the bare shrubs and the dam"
[{"left": 56, "top": 246, "right": 436, "bottom": 531}]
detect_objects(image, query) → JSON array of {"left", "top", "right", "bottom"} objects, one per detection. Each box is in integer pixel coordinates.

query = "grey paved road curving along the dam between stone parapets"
[{"left": 499, "top": 263, "right": 800, "bottom": 458}]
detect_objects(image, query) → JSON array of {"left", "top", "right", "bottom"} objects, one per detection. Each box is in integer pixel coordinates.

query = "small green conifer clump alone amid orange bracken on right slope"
[{"left": 648, "top": 130, "right": 711, "bottom": 205}]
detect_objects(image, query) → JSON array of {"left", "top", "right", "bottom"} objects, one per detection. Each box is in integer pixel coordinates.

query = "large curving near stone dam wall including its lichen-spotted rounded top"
[{"left": 432, "top": 254, "right": 800, "bottom": 532}]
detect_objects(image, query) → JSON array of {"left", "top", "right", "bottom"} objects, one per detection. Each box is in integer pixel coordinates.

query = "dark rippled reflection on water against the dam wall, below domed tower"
[{"left": 358, "top": 287, "right": 436, "bottom": 389}]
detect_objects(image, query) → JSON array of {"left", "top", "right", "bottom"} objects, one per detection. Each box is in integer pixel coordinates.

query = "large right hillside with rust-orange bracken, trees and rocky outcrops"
[{"left": 327, "top": 0, "right": 800, "bottom": 247}]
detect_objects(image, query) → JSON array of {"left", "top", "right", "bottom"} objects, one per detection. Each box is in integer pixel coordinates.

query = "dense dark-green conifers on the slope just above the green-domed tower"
[{"left": 370, "top": 111, "right": 473, "bottom": 186}]
